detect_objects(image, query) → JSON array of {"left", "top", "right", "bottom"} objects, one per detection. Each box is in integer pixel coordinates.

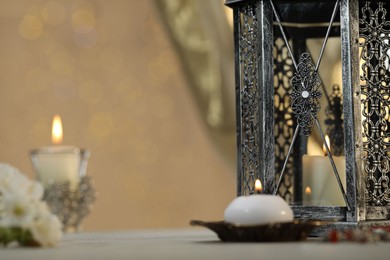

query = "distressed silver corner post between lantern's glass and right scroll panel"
[{"left": 340, "top": 0, "right": 365, "bottom": 221}]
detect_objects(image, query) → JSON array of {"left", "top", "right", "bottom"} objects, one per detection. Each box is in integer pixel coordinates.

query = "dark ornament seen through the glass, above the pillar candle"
[{"left": 325, "top": 84, "right": 344, "bottom": 156}]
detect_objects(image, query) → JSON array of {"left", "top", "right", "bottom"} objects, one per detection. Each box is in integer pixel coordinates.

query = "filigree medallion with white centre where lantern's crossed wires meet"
[{"left": 291, "top": 53, "right": 322, "bottom": 136}]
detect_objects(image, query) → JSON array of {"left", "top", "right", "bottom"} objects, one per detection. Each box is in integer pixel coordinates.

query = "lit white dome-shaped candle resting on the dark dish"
[{"left": 224, "top": 180, "right": 294, "bottom": 226}]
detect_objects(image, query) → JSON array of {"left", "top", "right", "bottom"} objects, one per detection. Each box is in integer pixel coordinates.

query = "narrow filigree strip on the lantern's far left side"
[{"left": 239, "top": 4, "right": 260, "bottom": 195}]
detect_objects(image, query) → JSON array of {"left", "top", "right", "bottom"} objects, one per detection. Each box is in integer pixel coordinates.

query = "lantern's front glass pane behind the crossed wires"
[{"left": 273, "top": 13, "right": 346, "bottom": 209}]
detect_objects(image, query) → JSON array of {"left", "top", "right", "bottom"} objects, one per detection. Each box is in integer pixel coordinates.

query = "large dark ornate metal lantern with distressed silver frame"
[{"left": 226, "top": 0, "right": 390, "bottom": 232}]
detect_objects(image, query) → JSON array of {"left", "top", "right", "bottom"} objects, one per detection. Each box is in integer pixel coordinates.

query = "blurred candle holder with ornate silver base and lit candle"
[{"left": 30, "top": 116, "right": 96, "bottom": 232}]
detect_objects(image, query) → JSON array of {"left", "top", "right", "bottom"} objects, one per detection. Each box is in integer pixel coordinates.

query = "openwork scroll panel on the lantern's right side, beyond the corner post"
[{"left": 359, "top": 1, "right": 390, "bottom": 206}]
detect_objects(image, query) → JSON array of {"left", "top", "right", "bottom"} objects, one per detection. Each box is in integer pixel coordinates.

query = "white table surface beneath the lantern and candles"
[{"left": 0, "top": 228, "right": 390, "bottom": 260}]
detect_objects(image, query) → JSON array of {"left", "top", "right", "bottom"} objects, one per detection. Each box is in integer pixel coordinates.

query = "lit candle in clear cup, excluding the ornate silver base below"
[{"left": 31, "top": 115, "right": 89, "bottom": 189}]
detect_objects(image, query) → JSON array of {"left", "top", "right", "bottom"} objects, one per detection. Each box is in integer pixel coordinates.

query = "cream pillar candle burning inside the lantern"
[{"left": 302, "top": 136, "right": 346, "bottom": 206}]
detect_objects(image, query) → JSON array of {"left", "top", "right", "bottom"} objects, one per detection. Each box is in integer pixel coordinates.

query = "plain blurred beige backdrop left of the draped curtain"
[{"left": 0, "top": 0, "right": 236, "bottom": 230}]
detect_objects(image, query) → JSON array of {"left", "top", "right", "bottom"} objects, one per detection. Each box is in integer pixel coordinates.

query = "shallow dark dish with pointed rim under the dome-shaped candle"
[{"left": 190, "top": 220, "right": 323, "bottom": 242}]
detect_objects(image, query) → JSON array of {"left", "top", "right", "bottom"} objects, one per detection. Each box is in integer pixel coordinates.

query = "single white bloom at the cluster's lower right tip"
[{"left": 30, "top": 207, "right": 62, "bottom": 247}]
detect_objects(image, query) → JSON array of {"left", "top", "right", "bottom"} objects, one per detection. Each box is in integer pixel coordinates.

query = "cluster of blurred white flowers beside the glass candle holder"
[{"left": 0, "top": 163, "right": 62, "bottom": 246}]
